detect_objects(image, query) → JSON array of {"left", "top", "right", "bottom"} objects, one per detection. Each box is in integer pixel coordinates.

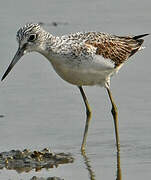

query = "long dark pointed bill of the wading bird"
[{"left": 1, "top": 48, "right": 24, "bottom": 81}]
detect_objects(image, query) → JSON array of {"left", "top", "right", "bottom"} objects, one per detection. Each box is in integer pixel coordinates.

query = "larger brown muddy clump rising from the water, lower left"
[{"left": 0, "top": 148, "right": 74, "bottom": 173}]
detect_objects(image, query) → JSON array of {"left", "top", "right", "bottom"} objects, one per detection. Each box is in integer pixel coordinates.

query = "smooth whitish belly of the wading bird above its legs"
[{"left": 51, "top": 55, "right": 115, "bottom": 86}]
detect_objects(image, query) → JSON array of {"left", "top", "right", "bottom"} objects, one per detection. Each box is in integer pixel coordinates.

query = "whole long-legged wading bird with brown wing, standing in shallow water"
[{"left": 2, "top": 23, "right": 148, "bottom": 151}]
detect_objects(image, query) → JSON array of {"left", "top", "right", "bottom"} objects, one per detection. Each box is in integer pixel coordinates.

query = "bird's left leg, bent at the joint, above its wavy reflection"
[{"left": 78, "top": 86, "right": 92, "bottom": 151}]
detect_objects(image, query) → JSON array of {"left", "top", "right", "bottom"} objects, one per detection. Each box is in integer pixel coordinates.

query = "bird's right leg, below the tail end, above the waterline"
[{"left": 106, "top": 87, "right": 120, "bottom": 152}]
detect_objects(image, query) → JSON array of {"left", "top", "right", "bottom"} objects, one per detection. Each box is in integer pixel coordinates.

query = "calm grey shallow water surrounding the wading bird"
[{"left": 0, "top": 0, "right": 151, "bottom": 180}]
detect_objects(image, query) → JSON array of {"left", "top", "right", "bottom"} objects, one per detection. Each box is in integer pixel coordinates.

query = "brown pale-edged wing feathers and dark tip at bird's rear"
[{"left": 86, "top": 34, "right": 147, "bottom": 67}]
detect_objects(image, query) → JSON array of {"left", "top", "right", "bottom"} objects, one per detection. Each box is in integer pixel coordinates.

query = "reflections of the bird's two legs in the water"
[{"left": 81, "top": 151, "right": 122, "bottom": 180}]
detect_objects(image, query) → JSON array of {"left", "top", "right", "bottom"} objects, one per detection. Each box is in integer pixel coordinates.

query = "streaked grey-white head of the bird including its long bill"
[{"left": 1, "top": 23, "right": 49, "bottom": 80}]
